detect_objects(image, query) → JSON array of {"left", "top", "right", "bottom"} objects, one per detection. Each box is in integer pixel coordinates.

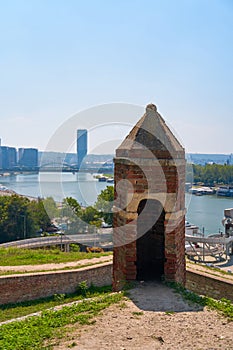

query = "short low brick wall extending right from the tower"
[{"left": 185, "top": 268, "right": 233, "bottom": 302}]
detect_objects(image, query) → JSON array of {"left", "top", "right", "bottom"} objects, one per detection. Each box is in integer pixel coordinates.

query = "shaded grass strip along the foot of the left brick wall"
[{"left": 0, "top": 284, "right": 112, "bottom": 322}]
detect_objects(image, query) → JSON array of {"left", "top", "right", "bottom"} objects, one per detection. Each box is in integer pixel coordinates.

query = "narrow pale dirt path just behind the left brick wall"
[{"left": 0, "top": 255, "right": 112, "bottom": 272}]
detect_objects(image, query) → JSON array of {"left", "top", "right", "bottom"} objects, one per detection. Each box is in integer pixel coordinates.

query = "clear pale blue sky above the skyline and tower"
[{"left": 0, "top": 0, "right": 233, "bottom": 153}]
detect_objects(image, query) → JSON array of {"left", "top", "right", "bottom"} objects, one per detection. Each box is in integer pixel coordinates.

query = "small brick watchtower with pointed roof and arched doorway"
[{"left": 113, "top": 104, "right": 185, "bottom": 290}]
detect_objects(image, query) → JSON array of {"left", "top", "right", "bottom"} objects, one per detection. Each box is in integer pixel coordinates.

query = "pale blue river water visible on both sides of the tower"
[{"left": 0, "top": 173, "right": 233, "bottom": 235}]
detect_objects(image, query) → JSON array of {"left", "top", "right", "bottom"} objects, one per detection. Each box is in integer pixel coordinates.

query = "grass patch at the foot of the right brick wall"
[{"left": 167, "top": 283, "right": 233, "bottom": 322}]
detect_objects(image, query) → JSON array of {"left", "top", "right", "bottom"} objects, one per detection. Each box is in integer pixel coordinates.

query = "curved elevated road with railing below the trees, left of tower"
[{"left": 0, "top": 233, "right": 113, "bottom": 252}]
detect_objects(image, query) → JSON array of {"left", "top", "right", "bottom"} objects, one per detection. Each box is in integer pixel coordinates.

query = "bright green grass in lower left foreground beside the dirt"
[{"left": 0, "top": 293, "right": 124, "bottom": 350}]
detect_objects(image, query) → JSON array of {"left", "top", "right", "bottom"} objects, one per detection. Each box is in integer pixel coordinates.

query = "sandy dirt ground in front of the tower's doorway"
[{"left": 54, "top": 282, "right": 233, "bottom": 350}]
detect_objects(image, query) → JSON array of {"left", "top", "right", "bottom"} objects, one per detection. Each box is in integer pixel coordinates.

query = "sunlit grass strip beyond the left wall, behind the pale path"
[{"left": 0, "top": 248, "right": 112, "bottom": 266}]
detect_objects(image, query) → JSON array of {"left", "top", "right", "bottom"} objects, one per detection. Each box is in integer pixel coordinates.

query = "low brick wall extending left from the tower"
[{"left": 0, "top": 262, "right": 112, "bottom": 304}]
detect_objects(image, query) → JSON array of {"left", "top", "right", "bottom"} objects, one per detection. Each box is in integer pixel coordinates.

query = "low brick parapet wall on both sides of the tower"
[{"left": 0, "top": 262, "right": 233, "bottom": 304}]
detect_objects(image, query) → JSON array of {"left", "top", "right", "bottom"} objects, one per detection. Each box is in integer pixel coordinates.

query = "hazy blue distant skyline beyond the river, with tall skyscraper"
[{"left": 0, "top": 134, "right": 233, "bottom": 173}]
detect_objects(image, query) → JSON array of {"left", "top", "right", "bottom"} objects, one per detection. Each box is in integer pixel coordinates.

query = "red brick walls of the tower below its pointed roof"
[{"left": 113, "top": 157, "right": 185, "bottom": 290}]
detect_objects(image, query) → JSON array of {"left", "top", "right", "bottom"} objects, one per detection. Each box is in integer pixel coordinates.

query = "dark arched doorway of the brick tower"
[{"left": 136, "top": 199, "right": 165, "bottom": 281}]
